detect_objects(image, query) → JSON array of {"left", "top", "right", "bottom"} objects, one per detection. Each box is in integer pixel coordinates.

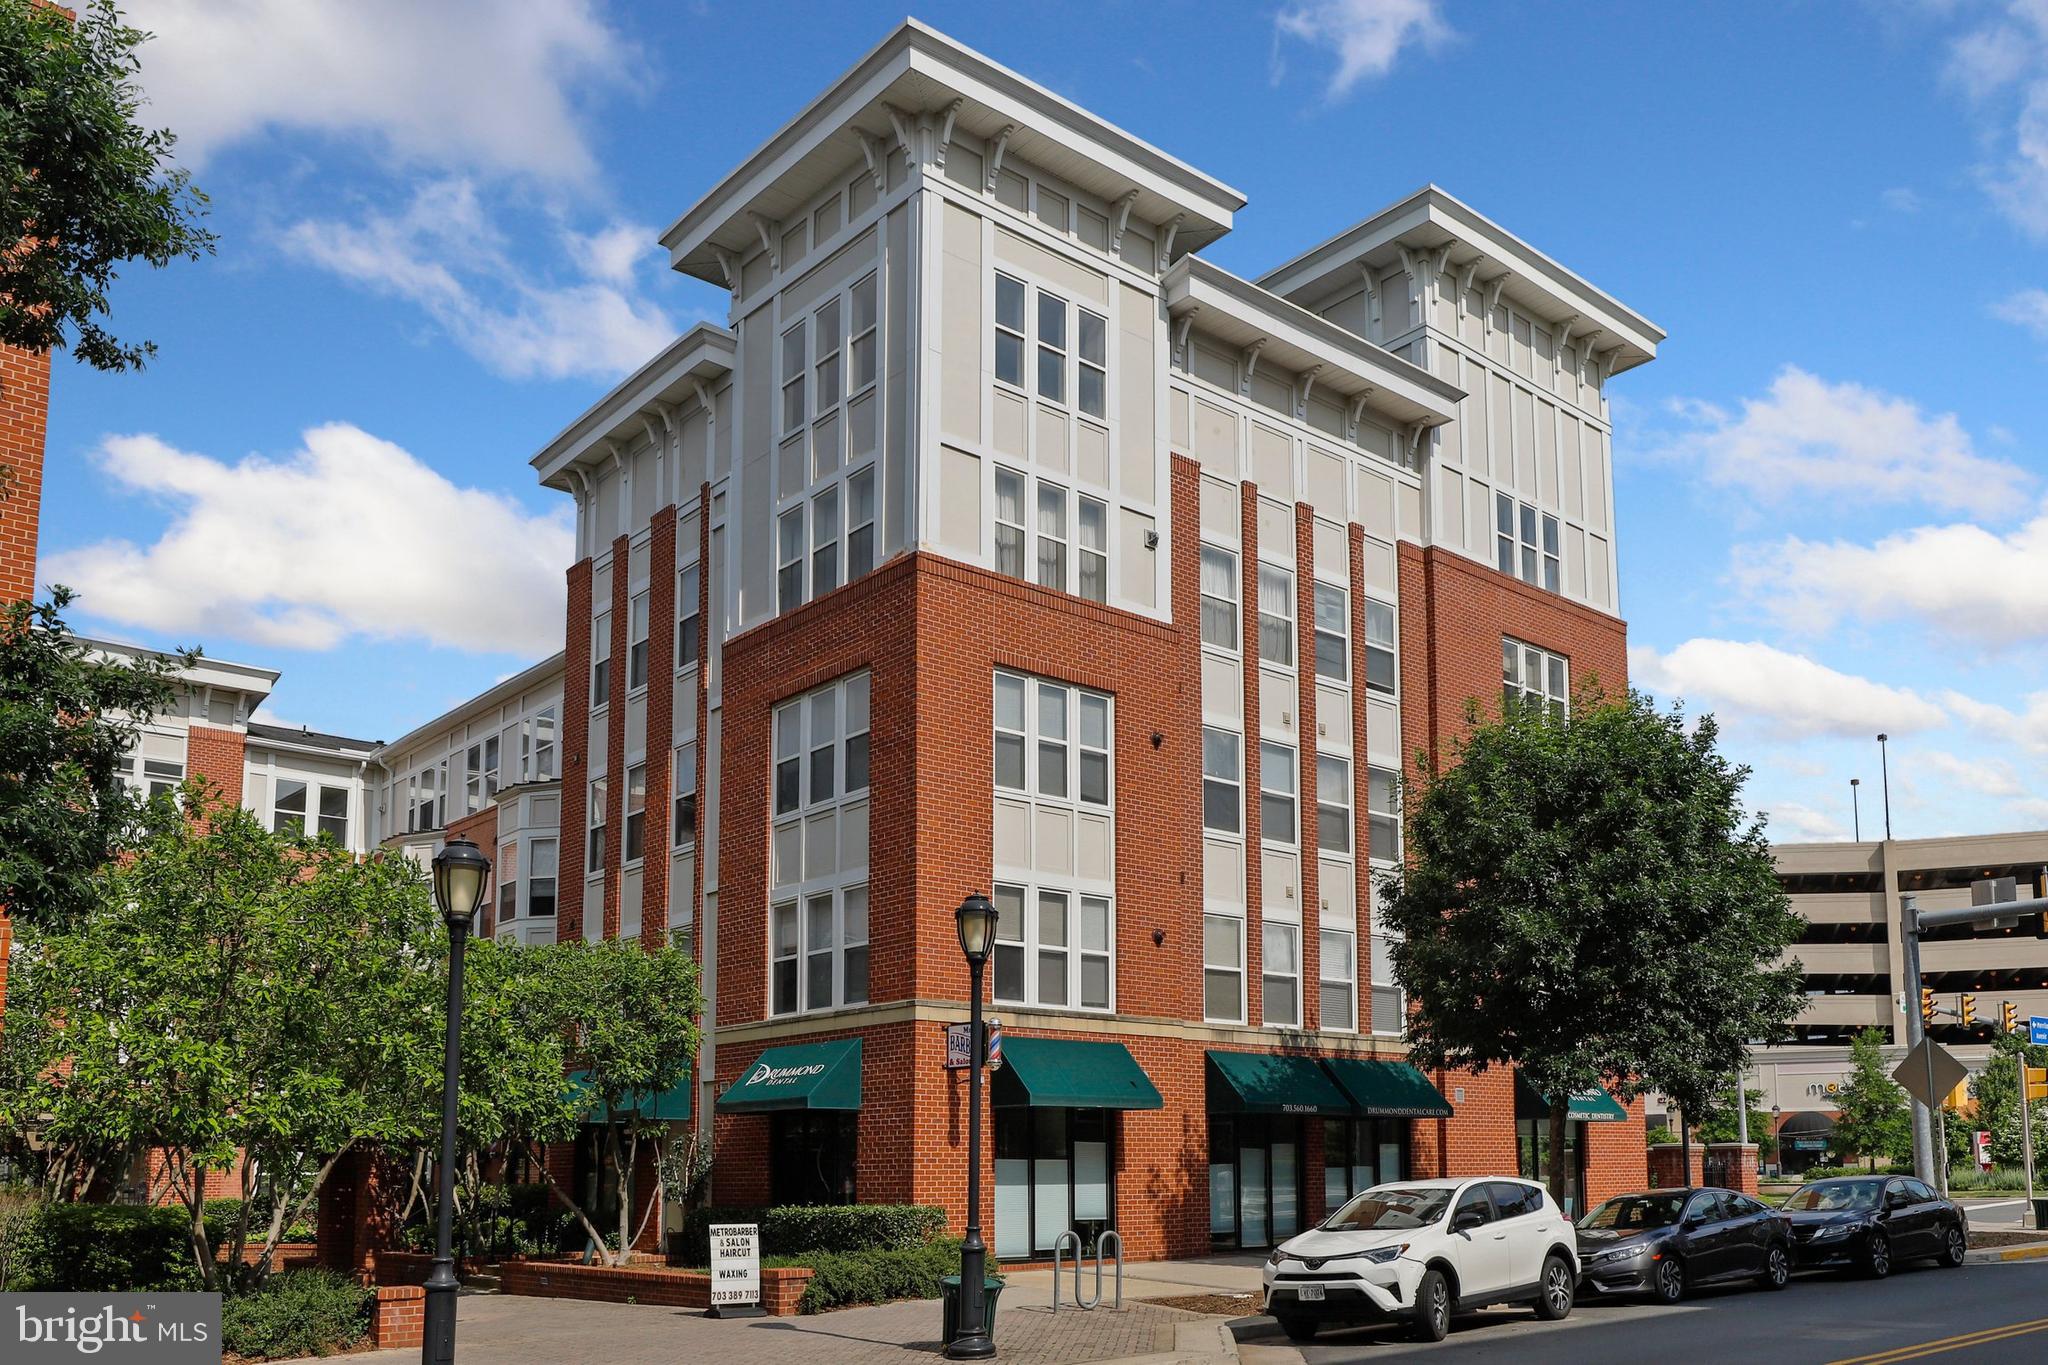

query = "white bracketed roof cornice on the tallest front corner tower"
[{"left": 662, "top": 18, "right": 1245, "bottom": 284}]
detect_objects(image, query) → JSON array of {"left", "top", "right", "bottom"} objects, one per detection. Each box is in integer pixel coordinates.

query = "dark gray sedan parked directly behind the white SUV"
[{"left": 1579, "top": 1189, "right": 1792, "bottom": 1304}]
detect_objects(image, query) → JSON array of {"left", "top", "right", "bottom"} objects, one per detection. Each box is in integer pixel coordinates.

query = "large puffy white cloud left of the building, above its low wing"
[{"left": 43, "top": 424, "right": 571, "bottom": 655}]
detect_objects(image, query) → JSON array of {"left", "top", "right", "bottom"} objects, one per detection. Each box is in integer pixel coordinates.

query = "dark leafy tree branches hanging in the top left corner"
[{"left": 0, "top": 0, "right": 213, "bottom": 370}]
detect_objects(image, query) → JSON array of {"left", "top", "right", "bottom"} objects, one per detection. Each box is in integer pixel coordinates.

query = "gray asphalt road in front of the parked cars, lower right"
[{"left": 1233, "top": 1261, "right": 2048, "bottom": 1365}]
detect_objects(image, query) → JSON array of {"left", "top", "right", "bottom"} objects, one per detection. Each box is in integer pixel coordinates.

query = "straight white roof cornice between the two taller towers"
[{"left": 1161, "top": 256, "right": 1464, "bottom": 426}]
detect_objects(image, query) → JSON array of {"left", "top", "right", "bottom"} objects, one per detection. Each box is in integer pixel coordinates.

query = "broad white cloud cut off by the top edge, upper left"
[{"left": 123, "top": 0, "right": 633, "bottom": 182}]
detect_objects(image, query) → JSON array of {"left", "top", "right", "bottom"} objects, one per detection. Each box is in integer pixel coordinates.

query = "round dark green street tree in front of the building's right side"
[{"left": 1380, "top": 692, "right": 1804, "bottom": 1197}]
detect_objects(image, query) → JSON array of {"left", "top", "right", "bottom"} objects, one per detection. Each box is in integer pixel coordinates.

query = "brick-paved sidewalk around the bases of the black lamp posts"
[{"left": 303, "top": 1293, "right": 1202, "bottom": 1365}]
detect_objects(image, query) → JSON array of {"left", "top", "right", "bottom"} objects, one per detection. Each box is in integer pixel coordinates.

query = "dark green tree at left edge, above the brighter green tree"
[{"left": 0, "top": 593, "right": 197, "bottom": 929}]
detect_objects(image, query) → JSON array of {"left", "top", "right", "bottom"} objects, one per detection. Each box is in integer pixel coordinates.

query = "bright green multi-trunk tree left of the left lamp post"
[{"left": 0, "top": 782, "right": 444, "bottom": 1289}]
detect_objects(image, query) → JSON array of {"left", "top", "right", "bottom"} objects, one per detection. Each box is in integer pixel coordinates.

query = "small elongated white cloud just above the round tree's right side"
[{"left": 1628, "top": 639, "right": 1946, "bottom": 739}]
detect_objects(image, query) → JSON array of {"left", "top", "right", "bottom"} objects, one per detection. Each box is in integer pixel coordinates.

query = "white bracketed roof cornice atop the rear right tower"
[{"left": 1257, "top": 184, "right": 1665, "bottom": 372}]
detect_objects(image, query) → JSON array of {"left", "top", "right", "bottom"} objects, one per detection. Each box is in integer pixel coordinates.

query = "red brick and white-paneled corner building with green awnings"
[{"left": 499, "top": 23, "right": 1663, "bottom": 1257}]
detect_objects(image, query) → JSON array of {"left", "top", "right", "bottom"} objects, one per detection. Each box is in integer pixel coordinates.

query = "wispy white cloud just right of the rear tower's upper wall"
[{"left": 1653, "top": 364, "right": 2030, "bottom": 516}]
